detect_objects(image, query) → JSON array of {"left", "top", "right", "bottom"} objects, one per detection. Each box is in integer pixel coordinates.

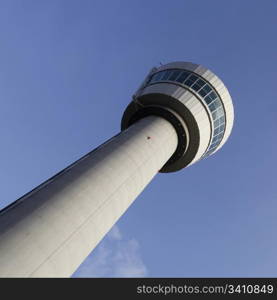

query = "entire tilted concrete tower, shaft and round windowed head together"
[{"left": 0, "top": 62, "right": 234, "bottom": 277}]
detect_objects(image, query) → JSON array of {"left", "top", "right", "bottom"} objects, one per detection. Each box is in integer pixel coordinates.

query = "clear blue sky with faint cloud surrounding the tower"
[{"left": 0, "top": 0, "right": 277, "bottom": 277}]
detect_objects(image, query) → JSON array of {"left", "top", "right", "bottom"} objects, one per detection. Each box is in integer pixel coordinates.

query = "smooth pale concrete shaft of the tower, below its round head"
[{"left": 0, "top": 116, "right": 178, "bottom": 277}]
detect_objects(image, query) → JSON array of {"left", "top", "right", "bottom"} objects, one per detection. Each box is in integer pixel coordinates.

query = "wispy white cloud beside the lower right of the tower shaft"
[{"left": 73, "top": 225, "right": 148, "bottom": 277}]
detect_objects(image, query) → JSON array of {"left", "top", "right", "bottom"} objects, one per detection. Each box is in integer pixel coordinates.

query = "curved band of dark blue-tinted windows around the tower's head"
[{"left": 148, "top": 69, "right": 225, "bottom": 157}]
